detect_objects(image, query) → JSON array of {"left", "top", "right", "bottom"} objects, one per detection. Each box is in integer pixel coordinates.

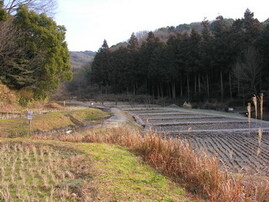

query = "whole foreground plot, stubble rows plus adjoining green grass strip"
[{"left": 0, "top": 139, "right": 190, "bottom": 201}]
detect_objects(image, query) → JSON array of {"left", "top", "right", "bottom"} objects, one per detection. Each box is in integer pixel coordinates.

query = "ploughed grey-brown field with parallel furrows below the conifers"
[{"left": 118, "top": 105, "right": 269, "bottom": 177}]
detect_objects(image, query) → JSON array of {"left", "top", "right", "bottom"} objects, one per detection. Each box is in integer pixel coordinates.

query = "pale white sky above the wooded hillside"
[{"left": 55, "top": 0, "right": 269, "bottom": 51}]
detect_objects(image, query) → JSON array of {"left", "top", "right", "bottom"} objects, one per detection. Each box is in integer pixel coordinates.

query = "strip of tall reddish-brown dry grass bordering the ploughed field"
[{"left": 35, "top": 128, "right": 269, "bottom": 201}]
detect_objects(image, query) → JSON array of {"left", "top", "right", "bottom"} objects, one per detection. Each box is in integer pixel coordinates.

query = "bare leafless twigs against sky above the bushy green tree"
[{"left": 5, "top": 0, "right": 56, "bottom": 16}]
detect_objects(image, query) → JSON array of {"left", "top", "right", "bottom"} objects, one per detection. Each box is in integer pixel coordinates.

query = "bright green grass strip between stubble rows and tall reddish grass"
[{"left": 79, "top": 143, "right": 186, "bottom": 201}]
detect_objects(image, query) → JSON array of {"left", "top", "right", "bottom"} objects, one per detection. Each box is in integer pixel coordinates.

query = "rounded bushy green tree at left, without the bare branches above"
[{"left": 0, "top": 6, "right": 72, "bottom": 99}]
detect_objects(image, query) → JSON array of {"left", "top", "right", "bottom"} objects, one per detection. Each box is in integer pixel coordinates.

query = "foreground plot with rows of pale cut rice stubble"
[{"left": 0, "top": 142, "right": 96, "bottom": 201}]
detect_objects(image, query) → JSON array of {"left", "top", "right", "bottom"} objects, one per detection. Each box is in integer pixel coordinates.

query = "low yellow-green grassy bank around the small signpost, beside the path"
[{"left": 0, "top": 108, "right": 109, "bottom": 137}]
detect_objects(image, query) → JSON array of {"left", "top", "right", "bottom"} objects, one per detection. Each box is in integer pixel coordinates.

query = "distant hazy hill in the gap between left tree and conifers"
[{"left": 70, "top": 51, "right": 96, "bottom": 69}]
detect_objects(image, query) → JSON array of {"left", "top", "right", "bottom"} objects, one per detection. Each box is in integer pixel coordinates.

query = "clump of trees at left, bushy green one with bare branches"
[{"left": 0, "top": 0, "right": 72, "bottom": 99}]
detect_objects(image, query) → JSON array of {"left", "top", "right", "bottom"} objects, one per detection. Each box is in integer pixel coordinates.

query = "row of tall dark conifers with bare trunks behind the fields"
[{"left": 87, "top": 9, "right": 269, "bottom": 101}]
